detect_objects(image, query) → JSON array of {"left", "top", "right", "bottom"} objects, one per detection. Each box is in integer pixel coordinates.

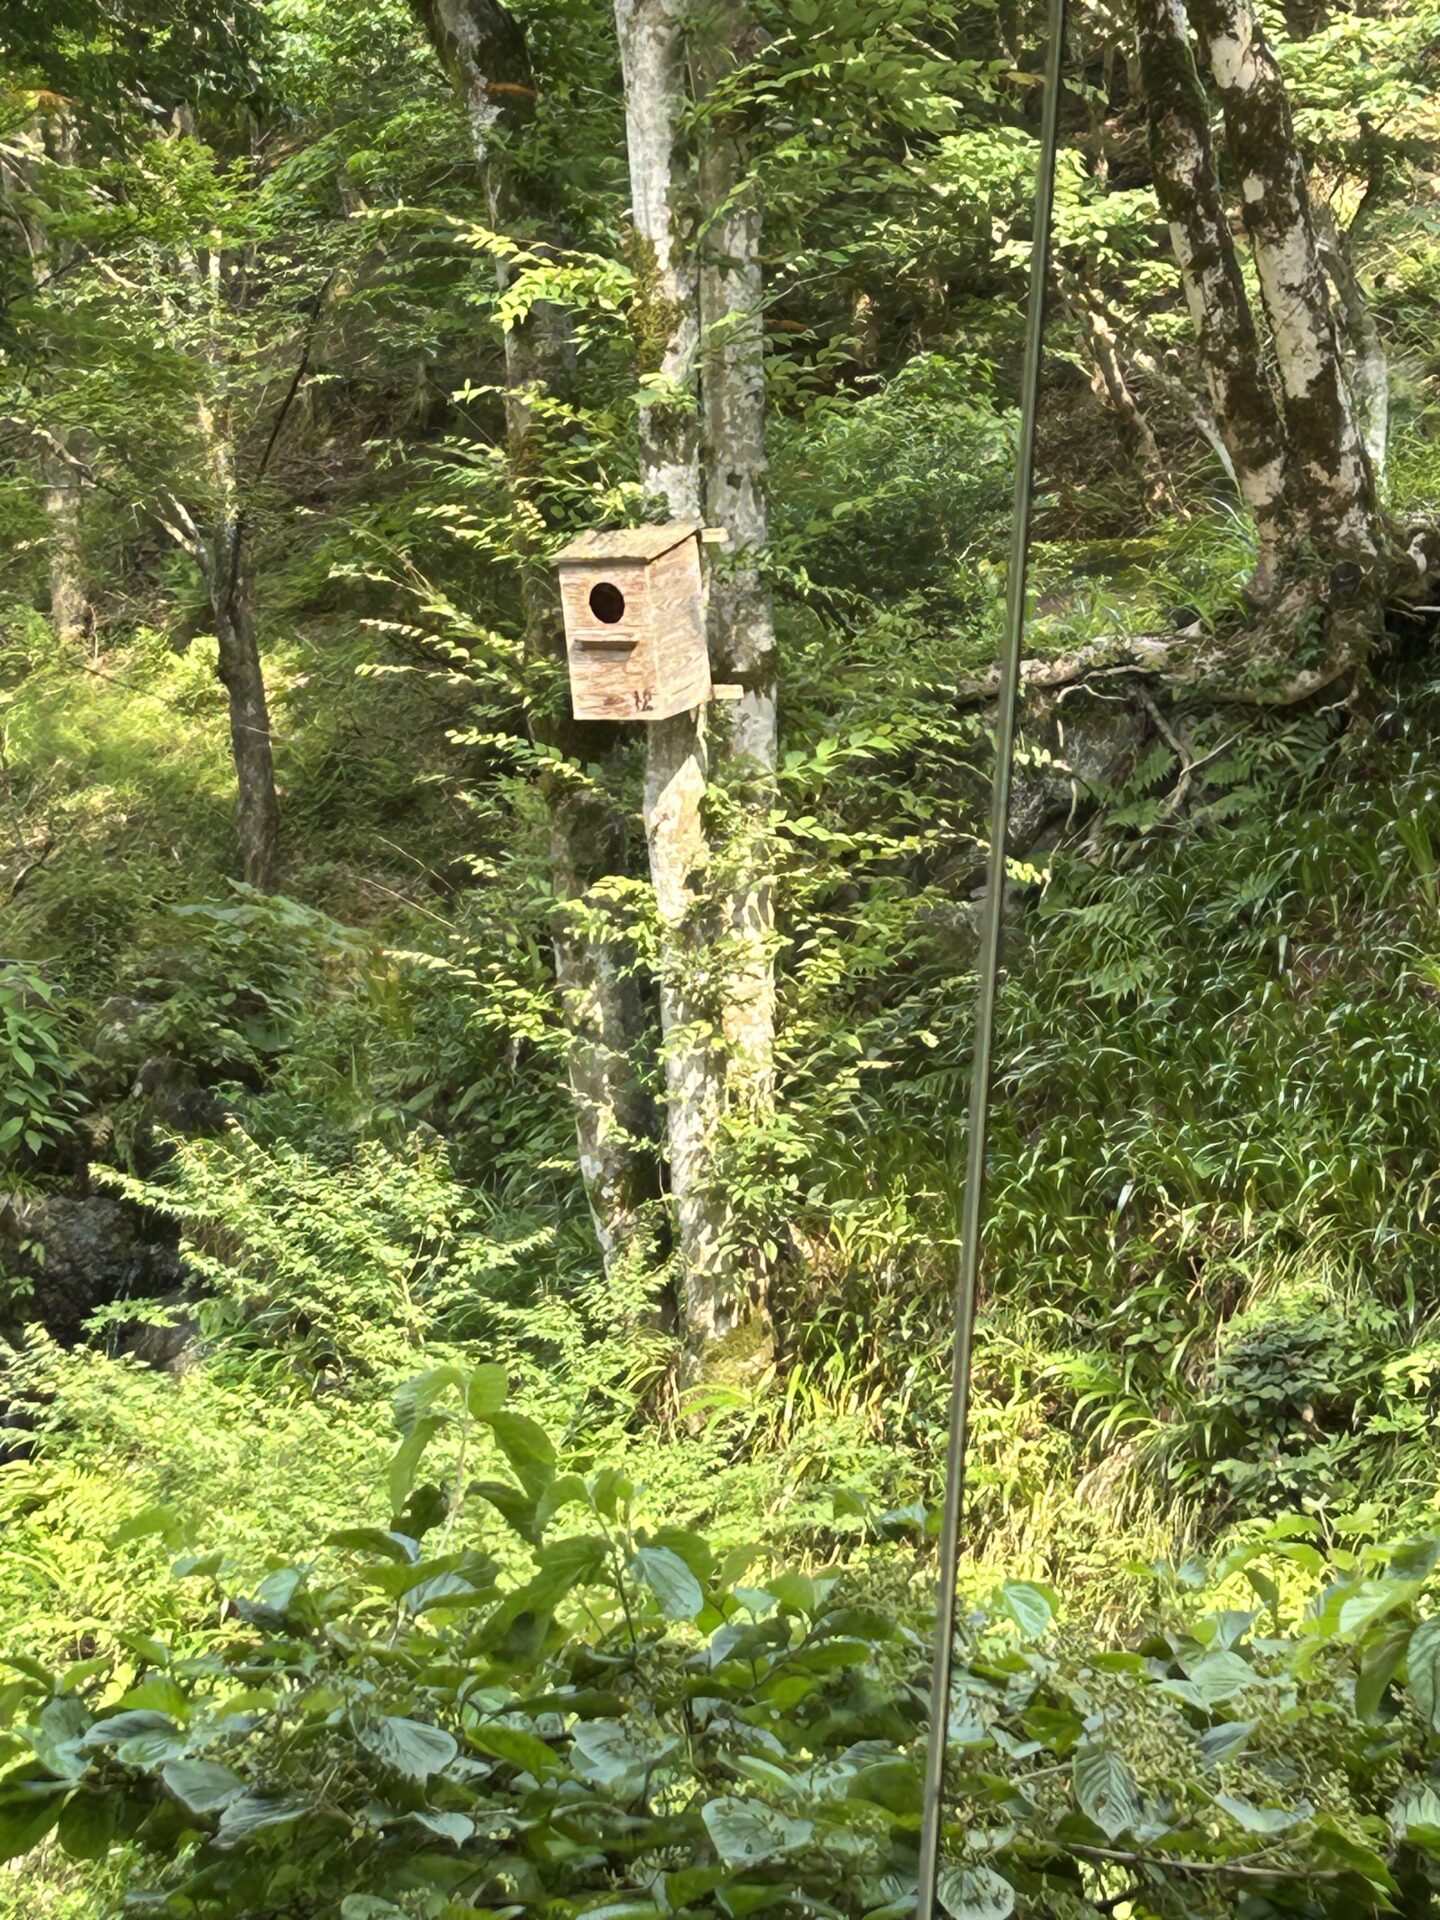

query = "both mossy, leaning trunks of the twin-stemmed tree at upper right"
[{"left": 1135, "top": 0, "right": 1384, "bottom": 660}]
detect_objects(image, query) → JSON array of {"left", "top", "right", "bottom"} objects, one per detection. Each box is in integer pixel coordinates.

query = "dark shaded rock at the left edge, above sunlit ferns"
[{"left": 0, "top": 1194, "right": 184, "bottom": 1346}]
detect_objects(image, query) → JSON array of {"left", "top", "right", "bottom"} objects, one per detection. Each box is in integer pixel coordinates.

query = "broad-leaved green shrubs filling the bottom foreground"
[{"left": 14, "top": 1365, "right": 1440, "bottom": 1920}]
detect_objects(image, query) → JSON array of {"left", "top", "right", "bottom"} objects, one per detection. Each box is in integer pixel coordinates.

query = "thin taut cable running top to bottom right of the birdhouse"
[{"left": 916, "top": 0, "right": 1066, "bottom": 1920}]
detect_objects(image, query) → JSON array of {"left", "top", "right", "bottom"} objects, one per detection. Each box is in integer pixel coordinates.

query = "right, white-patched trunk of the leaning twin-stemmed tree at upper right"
[{"left": 1190, "top": 0, "right": 1380, "bottom": 568}]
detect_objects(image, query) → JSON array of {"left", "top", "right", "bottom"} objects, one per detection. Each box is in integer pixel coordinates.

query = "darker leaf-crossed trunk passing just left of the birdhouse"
[{"left": 415, "top": 0, "right": 659, "bottom": 1273}]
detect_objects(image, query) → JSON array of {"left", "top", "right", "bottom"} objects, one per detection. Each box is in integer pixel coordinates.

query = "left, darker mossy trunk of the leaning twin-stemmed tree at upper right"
[{"left": 1135, "top": 0, "right": 1286, "bottom": 601}]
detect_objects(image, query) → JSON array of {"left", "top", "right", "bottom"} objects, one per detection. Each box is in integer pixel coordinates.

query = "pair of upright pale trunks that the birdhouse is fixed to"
[{"left": 614, "top": 0, "right": 776, "bottom": 1350}]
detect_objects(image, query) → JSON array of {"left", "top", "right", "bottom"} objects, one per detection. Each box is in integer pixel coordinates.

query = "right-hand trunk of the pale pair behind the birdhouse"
[{"left": 693, "top": 0, "right": 778, "bottom": 1116}]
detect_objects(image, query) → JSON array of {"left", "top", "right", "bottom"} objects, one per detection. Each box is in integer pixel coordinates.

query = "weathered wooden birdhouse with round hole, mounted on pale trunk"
[{"left": 557, "top": 520, "right": 712, "bottom": 720}]
